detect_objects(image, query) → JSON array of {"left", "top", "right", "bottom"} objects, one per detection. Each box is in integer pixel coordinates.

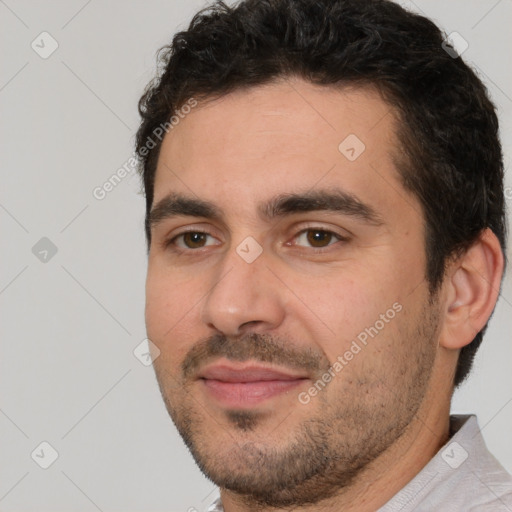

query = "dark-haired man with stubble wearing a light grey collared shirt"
[{"left": 137, "top": 0, "right": 512, "bottom": 512}]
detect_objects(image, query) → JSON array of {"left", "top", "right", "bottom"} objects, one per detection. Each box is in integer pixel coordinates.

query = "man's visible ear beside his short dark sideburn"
[{"left": 439, "top": 228, "right": 504, "bottom": 349}]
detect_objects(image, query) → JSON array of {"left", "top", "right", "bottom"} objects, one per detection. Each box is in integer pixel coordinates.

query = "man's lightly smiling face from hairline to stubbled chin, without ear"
[{"left": 146, "top": 81, "right": 439, "bottom": 505}]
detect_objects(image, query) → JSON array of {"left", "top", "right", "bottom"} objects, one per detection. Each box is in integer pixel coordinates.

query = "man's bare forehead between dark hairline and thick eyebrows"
[{"left": 154, "top": 80, "right": 405, "bottom": 218}]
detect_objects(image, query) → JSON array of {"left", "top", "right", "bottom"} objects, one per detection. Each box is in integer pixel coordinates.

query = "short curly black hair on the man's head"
[{"left": 136, "top": 0, "right": 506, "bottom": 386}]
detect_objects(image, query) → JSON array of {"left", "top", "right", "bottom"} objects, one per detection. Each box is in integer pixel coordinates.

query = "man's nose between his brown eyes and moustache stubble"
[{"left": 201, "top": 243, "right": 285, "bottom": 337}]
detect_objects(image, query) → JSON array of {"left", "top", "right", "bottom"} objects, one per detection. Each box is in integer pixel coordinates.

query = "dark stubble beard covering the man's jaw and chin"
[{"left": 155, "top": 303, "right": 439, "bottom": 509}]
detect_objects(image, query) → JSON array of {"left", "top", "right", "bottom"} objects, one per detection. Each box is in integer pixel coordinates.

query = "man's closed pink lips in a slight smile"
[{"left": 198, "top": 363, "right": 309, "bottom": 408}]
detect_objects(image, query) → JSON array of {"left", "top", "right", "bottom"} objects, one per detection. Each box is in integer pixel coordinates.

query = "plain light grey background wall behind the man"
[{"left": 0, "top": 0, "right": 512, "bottom": 512}]
